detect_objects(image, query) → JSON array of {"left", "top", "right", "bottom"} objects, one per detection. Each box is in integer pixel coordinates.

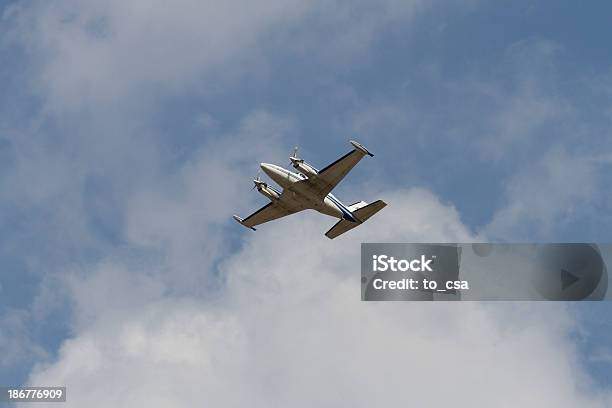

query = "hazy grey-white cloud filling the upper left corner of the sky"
[{"left": 3, "top": 0, "right": 303, "bottom": 111}]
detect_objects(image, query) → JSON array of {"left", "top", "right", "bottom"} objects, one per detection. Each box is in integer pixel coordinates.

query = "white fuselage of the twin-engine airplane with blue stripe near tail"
[{"left": 261, "top": 163, "right": 358, "bottom": 222}]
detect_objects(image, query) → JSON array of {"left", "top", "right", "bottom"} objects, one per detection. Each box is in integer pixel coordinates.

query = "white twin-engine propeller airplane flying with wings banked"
[{"left": 234, "top": 140, "right": 387, "bottom": 239}]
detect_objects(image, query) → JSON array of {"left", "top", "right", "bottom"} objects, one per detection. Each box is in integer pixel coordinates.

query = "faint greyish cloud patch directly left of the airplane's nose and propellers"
[{"left": 124, "top": 111, "right": 293, "bottom": 290}]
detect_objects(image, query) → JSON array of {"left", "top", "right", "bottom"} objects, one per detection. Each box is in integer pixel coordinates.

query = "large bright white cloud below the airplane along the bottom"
[{"left": 22, "top": 186, "right": 610, "bottom": 407}]
